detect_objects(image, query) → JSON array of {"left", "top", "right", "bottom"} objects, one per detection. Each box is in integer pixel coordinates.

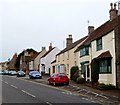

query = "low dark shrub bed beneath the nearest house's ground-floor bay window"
[{"left": 97, "top": 83, "right": 115, "bottom": 90}]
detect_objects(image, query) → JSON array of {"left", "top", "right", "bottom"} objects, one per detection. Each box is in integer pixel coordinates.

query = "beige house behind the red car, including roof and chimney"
[{"left": 51, "top": 35, "right": 87, "bottom": 77}]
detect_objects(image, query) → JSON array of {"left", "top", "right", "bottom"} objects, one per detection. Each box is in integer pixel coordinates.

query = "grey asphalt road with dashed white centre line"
[{"left": 1, "top": 76, "right": 99, "bottom": 105}]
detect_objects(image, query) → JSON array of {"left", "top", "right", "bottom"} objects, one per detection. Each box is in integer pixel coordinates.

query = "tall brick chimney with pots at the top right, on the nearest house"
[{"left": 109, "top": 3, "right": 118, "bottom": 20}]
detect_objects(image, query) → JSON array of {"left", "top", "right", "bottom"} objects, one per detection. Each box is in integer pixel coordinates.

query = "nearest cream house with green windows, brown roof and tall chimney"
[{"left": 75, "top": 4, "right": 120, "bottom": 86}]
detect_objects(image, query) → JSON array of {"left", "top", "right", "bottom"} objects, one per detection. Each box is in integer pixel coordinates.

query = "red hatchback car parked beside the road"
[{"left": 48, "top": 73, "right": 69, "bottom": 86}]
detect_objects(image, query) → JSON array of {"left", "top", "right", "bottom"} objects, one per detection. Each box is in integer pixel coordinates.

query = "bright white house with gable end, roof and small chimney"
[{"left": 39, "top": 43, "right": 60, "bottom": 74}]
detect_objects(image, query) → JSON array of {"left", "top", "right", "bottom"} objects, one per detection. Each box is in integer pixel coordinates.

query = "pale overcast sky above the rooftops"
[{"left": 0, "top": 0, "right": 118, "bottom": 62}]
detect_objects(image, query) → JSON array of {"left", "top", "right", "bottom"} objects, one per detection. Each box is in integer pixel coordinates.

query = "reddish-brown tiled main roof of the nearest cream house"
[{"left": 81, "top": 15, "right": 120, "bottom": 46}]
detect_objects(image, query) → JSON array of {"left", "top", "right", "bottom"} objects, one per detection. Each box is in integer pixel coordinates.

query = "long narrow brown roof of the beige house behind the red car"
[{"left": 57, "top": 36, "right": 88, "bottom": 55}]
